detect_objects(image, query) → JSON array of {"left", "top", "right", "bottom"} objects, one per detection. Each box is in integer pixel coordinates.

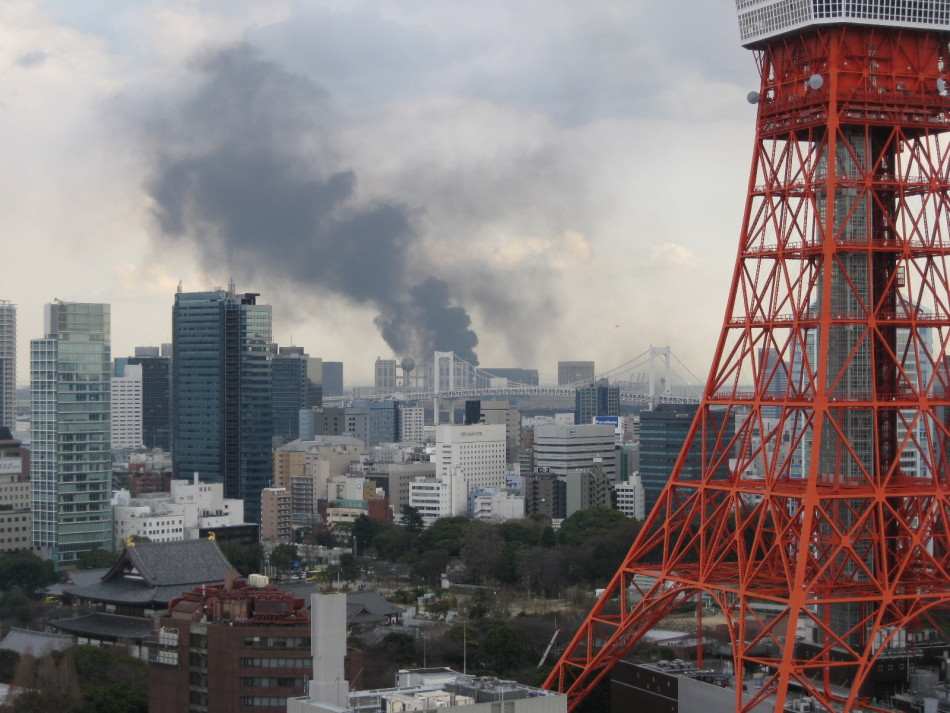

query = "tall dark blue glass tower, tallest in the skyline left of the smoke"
[{"left": 172, "top": 285, "right": 273, "bottom": 523}]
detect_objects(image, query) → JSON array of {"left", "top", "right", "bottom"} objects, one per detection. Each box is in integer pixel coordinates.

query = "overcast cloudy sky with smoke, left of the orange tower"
[{"left": 0, "top": 0, "right": 757, "bottom": 383}]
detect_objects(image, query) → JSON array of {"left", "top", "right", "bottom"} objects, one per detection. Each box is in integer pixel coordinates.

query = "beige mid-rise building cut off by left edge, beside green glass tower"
[{"left": 0, "top": 426, "right": 31, "bottom": 554}]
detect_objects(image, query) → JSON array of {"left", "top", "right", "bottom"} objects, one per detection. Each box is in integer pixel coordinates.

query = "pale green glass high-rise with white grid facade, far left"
[{"left": 30, "top": 301, "right": 112, "bottom": 567}]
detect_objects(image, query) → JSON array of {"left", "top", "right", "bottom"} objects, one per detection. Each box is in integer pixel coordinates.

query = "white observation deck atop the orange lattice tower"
[{"left": 736, "top": 0, "right": 950, "bottom": 47}]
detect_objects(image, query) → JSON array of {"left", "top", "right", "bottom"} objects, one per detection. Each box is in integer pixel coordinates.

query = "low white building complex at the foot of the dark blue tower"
[{"left": 112, "top": 475, "right": 244, "bottom": 549}]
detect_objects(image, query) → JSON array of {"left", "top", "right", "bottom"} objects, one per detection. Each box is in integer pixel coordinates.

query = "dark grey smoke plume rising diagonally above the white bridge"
[{"left": 147, "top": 44, "right": 478, "bottom": 364}]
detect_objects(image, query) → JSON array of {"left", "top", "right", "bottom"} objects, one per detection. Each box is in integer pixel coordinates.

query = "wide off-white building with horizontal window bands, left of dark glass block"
[{"left": 534, "top": 424, "right": 617, "bottom": 481}]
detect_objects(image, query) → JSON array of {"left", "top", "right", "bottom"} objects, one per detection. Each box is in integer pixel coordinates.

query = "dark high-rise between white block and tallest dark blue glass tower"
[{"left": 115, "top": 344, "right": 172, "bottom": 451}]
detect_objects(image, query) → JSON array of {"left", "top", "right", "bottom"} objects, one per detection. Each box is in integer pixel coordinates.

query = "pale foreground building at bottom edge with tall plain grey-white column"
[{"left": 286, "top": 594, "right": 567, "bottom": 713}]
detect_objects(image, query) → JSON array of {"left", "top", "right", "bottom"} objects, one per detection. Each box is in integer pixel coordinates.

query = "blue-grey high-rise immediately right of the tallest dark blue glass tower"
[{"left": 271, "top": 347, "right": 323, "bottom": 439}]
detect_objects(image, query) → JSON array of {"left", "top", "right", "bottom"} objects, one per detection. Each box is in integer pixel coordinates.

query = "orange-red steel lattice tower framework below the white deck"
[{"left": 545, "top": 19, "right": 950, "bottom": 711}]
